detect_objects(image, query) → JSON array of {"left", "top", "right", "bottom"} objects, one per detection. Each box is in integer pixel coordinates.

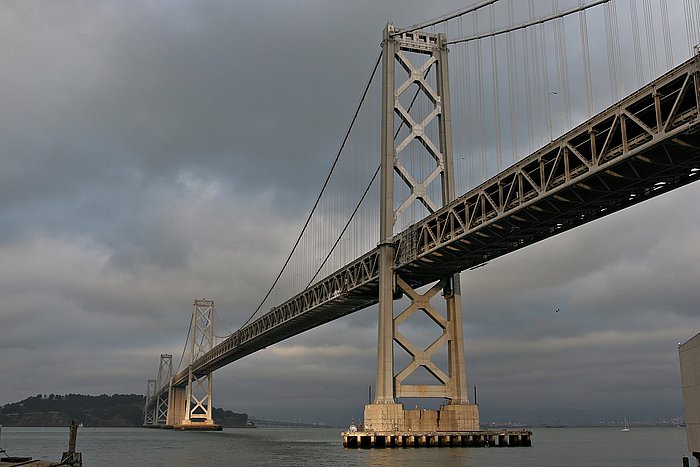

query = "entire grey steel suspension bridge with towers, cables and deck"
[{"left": 144, "top": 0, "right": 700, "bottom": 433}]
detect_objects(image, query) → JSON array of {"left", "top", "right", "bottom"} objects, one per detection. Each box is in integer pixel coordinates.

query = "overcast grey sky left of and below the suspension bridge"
[{"left": 0, "top": 0, "right": 700, "bottom": 424}]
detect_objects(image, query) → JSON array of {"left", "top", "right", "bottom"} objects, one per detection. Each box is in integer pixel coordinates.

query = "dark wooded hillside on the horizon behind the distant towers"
[{"left": 0, "top": 394, "right": 248, "bottom": 427}]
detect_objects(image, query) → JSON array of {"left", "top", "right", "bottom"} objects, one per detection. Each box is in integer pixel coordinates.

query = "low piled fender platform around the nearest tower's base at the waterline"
[{"left": 341, "top": 430, "right": 532, "bottom": 448}]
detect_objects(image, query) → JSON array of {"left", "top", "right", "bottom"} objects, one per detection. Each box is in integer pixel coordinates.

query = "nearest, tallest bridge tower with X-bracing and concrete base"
[{"left": 364, "top": 24, "right": 479, "bottom": 431}]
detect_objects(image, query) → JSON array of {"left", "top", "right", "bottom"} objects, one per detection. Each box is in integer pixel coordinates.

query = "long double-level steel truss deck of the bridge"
[{"left": 154, "top": 56, "right": 700, "bottom": 398}]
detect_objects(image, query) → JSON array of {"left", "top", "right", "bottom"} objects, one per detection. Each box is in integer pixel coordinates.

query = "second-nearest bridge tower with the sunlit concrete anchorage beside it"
[{"left": 167, "top": 299, "right": 215, "bottom": 429}]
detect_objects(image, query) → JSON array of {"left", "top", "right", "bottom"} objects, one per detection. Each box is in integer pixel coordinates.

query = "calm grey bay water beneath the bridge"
[{"left": 0, "top": 427, "right": 694, "bottom": 467}]
